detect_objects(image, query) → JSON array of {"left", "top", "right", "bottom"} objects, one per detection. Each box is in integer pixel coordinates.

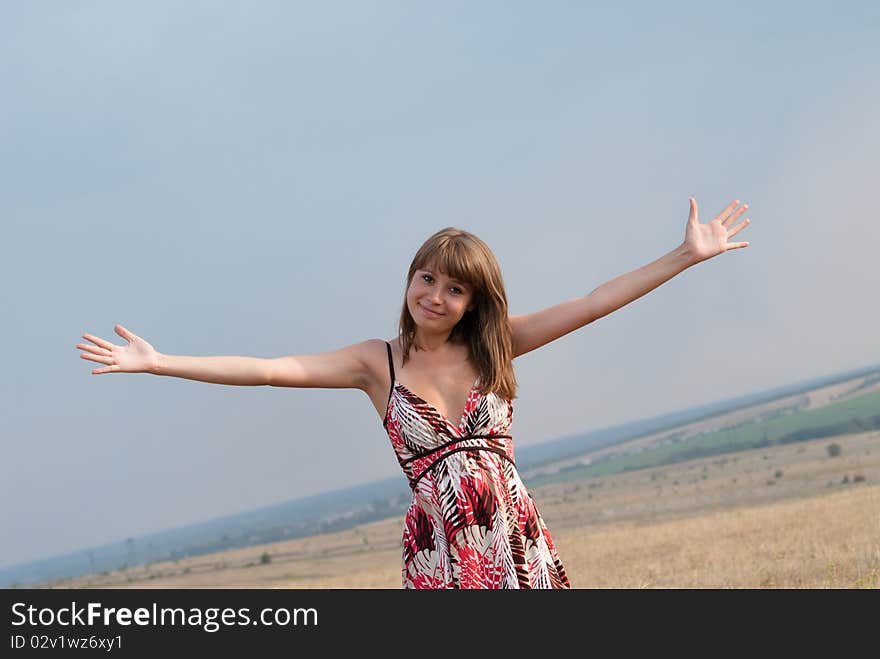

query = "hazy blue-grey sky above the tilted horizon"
[{"left": 0, "top": 1, "right": 880, "bottom": 565}]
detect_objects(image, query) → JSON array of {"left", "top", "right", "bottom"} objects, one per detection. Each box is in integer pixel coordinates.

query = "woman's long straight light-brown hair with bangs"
[{"left": 399, "top": 227, "right": 516, "bottom": 400}]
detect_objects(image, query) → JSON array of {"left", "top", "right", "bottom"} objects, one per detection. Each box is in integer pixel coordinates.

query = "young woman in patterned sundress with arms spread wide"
[{"left": 77, "top": 198, "right": 749, "bottom": 588}]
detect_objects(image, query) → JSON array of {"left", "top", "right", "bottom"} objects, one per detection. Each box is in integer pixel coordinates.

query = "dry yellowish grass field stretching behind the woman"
[{"left": 44, "top": 431, "right": 880, "bottom": 588}]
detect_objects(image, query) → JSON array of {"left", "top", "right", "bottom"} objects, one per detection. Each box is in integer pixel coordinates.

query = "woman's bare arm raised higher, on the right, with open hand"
[{"left": 510, "top": 197, "right": 749, "bottom": 357}]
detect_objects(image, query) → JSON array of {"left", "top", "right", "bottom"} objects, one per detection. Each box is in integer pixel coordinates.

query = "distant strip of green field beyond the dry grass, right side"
[{"left": 529, "top": 392, "right": 880, "bottom": 487}]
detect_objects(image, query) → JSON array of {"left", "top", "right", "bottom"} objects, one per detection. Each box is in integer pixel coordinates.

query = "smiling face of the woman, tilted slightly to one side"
[{"left": 406, "top": 265, "right": 473, "bottom": 334}]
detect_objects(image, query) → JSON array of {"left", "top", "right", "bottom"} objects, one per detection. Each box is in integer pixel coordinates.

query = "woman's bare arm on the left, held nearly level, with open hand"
[{"left": 77, "top": 325, "right": 377, "bottom": 391}]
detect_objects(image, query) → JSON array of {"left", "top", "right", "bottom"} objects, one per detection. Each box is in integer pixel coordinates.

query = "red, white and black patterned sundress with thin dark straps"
[{"left": 383, "top": 342, "right": 571, "bottom": 588}]
